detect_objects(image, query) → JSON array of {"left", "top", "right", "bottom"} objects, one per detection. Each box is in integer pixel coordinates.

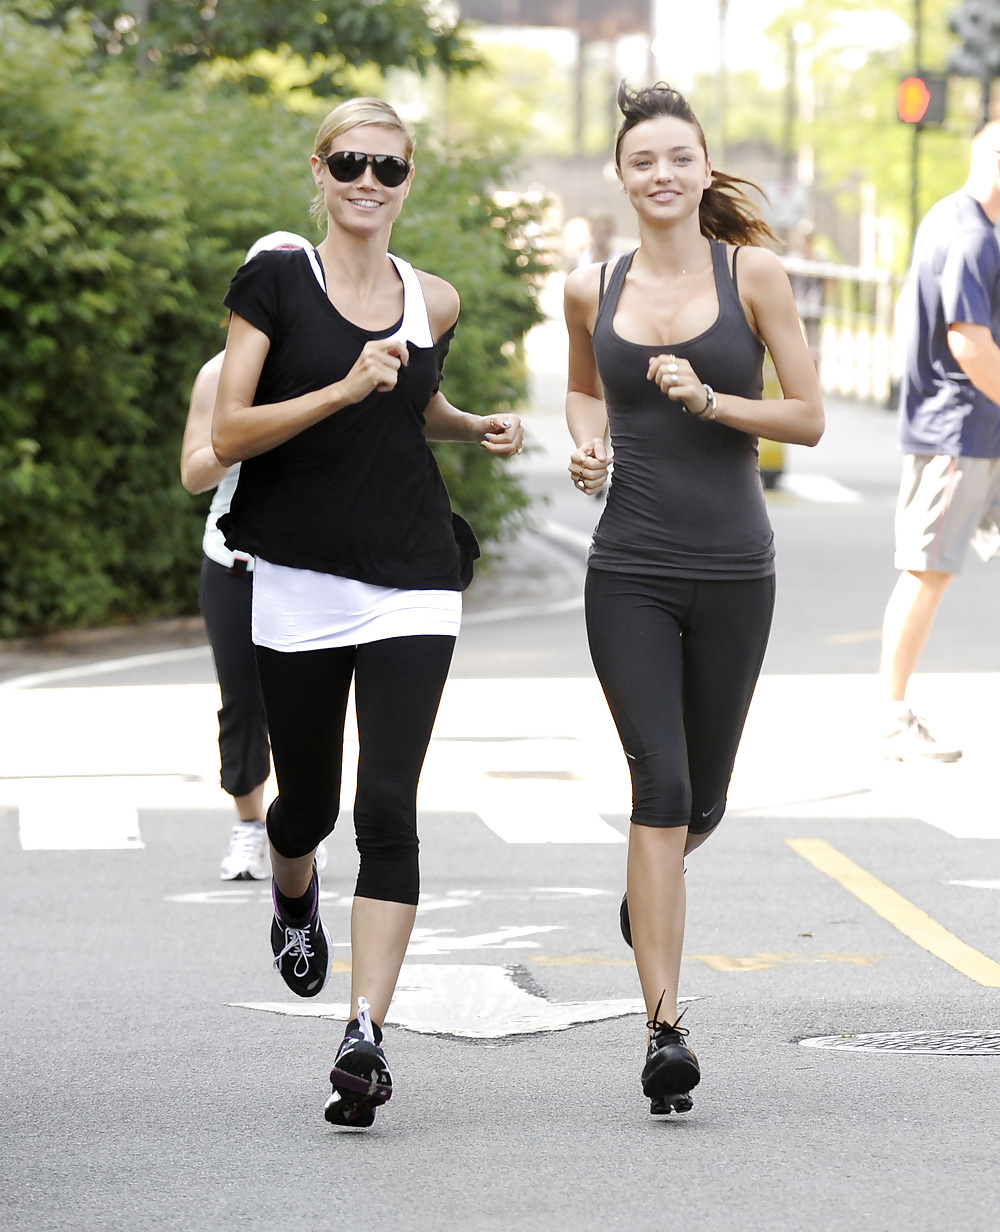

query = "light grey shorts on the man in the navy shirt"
[{"left": 895, "top": 453, "right": 1000, "bottom": 573}]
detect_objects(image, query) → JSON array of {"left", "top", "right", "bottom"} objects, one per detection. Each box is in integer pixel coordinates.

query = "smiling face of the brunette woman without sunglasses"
[{"left": 618, "top": 116, "right": 712, "bottom": 230}]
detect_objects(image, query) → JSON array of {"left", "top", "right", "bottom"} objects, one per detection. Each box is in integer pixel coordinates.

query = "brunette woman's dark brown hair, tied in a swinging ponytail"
[{"left": 615, "top": 81, "right": 777, "bottom": 244}]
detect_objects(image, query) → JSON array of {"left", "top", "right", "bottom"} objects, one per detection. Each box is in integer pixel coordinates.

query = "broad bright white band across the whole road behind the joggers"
[{"left": 0, "top": 673, "right": 1000, "bottom": 846}]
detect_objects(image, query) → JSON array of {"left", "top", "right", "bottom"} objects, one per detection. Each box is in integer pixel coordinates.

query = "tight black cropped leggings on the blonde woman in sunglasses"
[{"left": 257, "top": 636, "right": 454, "bottom": 904}]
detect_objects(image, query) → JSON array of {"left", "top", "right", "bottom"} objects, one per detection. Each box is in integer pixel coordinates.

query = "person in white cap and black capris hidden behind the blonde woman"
[{"left": 181, "top": 232, "right": 326, "bottom": 881}]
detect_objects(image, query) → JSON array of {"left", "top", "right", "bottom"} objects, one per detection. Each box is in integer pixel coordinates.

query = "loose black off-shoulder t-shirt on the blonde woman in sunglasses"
[{"left": 219, "top": 249, "right": 478, "bottom": 590}]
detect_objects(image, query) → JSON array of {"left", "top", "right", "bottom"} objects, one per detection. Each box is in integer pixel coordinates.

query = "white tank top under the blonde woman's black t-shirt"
[{"left": 250, "top": 248, "right": 462, "bottom": 652}]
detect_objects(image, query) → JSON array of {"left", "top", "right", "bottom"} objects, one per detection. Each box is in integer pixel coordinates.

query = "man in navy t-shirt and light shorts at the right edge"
[{"left": 881, "top": 123, "right": 1000, "bottom": 761}]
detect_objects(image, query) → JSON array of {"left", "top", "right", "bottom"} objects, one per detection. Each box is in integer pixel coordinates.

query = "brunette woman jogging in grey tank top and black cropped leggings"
[{"left": 565, "top": 77, "right": 824, "bottom": 1114}]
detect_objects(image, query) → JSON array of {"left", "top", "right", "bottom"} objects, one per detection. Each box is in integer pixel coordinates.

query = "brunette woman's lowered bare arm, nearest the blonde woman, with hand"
[{"left": 564, "top": 266, "right": 612, "bottom": 493}]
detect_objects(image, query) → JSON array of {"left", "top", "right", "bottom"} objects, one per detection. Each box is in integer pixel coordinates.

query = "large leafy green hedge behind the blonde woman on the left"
[{"left": 0, "top": 9, "right": 537, "bottom": 637}]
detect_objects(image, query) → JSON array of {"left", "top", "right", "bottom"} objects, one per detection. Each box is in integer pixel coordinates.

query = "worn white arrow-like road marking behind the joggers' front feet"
[{"left": 229, "top": 963, "right": 645, "bottom": 1040}]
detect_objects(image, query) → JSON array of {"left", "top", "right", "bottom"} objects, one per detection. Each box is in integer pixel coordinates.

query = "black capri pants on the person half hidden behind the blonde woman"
[{"left": 198, "top": 556, "right": 271, "bottom": 796}]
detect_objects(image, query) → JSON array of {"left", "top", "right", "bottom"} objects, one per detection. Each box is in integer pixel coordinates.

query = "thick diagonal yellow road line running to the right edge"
[{"left": 784, "top": 839, "right": 1000, "bottom": 988}]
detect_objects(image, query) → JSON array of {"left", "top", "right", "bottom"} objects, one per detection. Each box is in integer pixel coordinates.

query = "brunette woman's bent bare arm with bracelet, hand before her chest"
[{"left": 649, "top": 248, "right": 825, "bottom": 446}]
